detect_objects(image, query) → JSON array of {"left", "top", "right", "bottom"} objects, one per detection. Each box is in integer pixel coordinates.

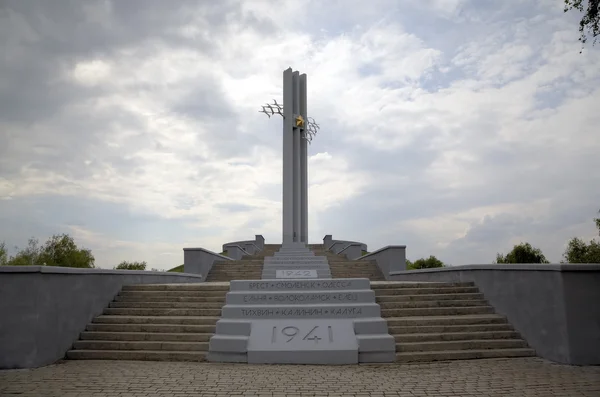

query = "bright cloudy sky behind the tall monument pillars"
[{"left": 0, "top": 0, "right": 600, "bottom": 269}]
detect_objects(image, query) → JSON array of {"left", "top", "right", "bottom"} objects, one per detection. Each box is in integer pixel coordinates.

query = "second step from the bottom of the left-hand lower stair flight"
[{"left": 73, "top": 340, "right": 208, "bottom": 351}]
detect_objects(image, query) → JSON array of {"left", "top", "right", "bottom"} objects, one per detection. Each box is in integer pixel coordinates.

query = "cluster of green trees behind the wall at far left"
[{"left": 0, "top": 234, "right": 94, "bottom": 268}]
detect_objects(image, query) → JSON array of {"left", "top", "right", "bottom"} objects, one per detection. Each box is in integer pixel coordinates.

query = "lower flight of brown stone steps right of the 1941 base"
[{"left": 371, "top": 282, "right": 535, "bottom": 362}]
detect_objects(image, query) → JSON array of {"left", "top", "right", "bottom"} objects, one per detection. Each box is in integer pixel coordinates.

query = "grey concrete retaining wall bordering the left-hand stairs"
[{"left": 0, "top": 266, "right": 202, "bottom": 369}]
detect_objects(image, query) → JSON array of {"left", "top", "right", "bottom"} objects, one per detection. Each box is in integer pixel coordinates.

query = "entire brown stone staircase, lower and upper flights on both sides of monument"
[{"left": 67, "top": 245, "right": 535, "bottom": 362}]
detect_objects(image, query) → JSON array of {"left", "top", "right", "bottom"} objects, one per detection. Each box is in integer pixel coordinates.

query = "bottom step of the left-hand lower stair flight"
[{"left": 67, "top": 350, "right": 206, "bottom": 361}]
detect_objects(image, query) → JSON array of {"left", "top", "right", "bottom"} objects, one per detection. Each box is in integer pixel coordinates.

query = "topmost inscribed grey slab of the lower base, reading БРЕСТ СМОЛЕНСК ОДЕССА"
[{"left": 229, "top": 278, "right": 371, "bottom": 291}]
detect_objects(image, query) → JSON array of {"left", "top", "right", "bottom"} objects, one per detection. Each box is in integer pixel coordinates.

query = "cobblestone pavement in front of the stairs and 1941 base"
[{"left": 0, "top": 358, "right": 600, "bottom": 397}]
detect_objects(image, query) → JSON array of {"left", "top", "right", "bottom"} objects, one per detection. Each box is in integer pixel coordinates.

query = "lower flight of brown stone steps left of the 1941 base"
[{"left": 67, "top": 283, "right": 229, "bottom": 361}]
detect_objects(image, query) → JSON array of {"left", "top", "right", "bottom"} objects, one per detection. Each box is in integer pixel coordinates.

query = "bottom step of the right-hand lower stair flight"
[{"left": 396, "top": 348, "right": 535, "bottom": 362}]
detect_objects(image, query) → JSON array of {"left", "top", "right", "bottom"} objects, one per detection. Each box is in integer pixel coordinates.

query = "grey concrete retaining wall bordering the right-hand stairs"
[{"left": 390, "top": 264, "right": 600, "bottom": 365}]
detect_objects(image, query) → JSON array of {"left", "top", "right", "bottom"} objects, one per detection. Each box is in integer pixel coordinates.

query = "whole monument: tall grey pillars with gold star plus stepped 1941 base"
[{"left": 207, "top": 68, "right": 396, "bottom": 364}]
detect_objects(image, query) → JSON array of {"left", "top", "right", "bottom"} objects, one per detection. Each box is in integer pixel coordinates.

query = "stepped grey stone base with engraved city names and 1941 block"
[{"left": 207, "top": 279, "right": 396, "bottom": 364}]
